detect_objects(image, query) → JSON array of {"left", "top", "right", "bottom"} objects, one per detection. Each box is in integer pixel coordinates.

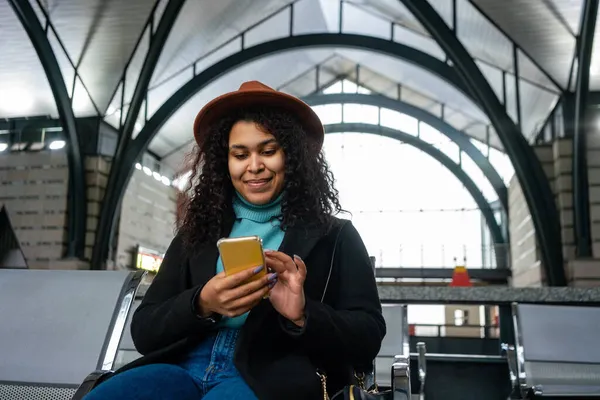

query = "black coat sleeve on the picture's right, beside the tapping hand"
[{"left": 284, "top": 222, "right": 386, "bottom": 366}]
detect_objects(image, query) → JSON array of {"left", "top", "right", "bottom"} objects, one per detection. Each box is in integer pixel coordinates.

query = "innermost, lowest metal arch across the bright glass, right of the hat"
[{"left": 325, "top": 123, "right": 508, "bottom": 268}]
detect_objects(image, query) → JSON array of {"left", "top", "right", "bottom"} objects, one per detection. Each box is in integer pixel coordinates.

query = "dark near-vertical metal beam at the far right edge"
[{"left": 573, "top": 0, "right": 598, "bottom": 257}]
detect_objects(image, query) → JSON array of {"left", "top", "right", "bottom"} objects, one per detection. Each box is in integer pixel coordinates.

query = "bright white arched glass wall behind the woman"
[{"left": 315, "top": 81, "right": 513, "bottom": 268}]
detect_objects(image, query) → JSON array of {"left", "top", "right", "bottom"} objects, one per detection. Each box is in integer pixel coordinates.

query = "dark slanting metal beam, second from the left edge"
[{"left": 91, "top": 0, "right": 185, "bottom": 269}]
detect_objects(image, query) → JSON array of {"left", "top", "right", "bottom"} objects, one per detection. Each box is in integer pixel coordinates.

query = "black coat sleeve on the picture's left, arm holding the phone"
[{"left": 131, "top": 236, "right": 217, "bottom": 355}]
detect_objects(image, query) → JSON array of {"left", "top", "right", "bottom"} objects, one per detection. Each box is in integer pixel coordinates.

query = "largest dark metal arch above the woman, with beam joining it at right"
[{"left": 91, "top": 0, "right": 566, "bottom": 285}]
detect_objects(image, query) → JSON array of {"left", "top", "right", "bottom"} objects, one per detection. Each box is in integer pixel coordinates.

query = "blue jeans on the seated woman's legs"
[{"left": 84, "top": 329, "right": 257, "bottom": 400}]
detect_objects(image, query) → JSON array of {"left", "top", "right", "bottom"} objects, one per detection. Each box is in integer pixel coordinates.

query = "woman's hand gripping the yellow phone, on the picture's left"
[{"left": 198, "top": 267, "right": 277, "bottom": 318}]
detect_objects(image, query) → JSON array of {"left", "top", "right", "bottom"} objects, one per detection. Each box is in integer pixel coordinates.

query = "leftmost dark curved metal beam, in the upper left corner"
[{"left": 9, "top": 0, "right": 87, "bottom": 258}]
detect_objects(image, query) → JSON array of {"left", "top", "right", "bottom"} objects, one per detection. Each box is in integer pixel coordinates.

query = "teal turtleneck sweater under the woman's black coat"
[{"left": 217, "top": 192, "right": 284, "bottom": 328}]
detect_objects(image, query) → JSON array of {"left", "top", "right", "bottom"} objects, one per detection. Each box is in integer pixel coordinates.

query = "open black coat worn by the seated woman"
[{"left": 120, "top": 219, "right": 386, "bottom": 400}]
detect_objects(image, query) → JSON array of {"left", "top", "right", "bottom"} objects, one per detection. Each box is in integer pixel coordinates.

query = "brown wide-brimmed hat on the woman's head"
[{"left": 194, "top": 81, "right": 325, "bottom": 151}]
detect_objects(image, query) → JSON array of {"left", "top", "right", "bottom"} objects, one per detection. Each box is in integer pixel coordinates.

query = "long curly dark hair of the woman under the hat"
[{"left": 177, "top": 107, "right": 342, "bottom": 249}]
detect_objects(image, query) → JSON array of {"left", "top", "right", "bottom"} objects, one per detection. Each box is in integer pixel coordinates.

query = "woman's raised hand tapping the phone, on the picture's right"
[{"left": 265, "top": 251, "right": 306, "bottom": 326}]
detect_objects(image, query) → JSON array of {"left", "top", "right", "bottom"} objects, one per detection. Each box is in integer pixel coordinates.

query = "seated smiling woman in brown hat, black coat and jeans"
[{"left": 87, "top": 82, "right": 386, "bottom": 400}]
